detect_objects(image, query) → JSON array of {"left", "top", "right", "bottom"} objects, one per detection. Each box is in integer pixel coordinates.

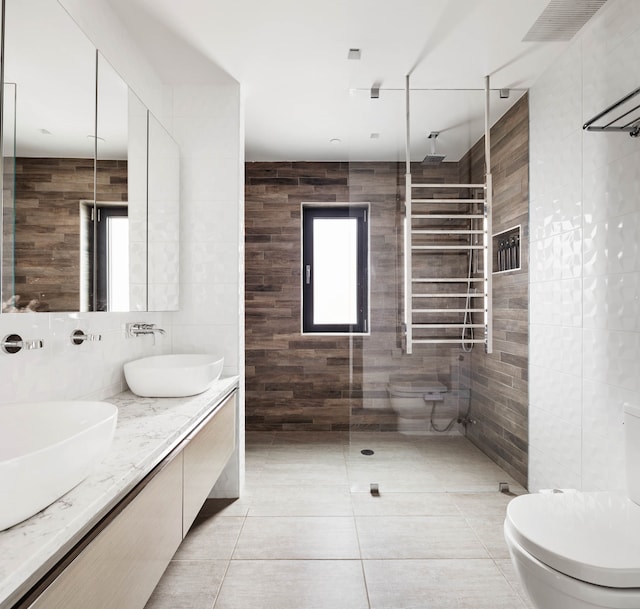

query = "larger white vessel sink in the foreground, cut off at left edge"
[{"left": 0, "top": 401, "right": 118, "bottom": 531}]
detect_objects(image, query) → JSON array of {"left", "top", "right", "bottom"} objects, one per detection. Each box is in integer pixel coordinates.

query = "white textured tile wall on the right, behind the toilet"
[{"left": 529, "top": 0, "right": 640, "bottom": 491}]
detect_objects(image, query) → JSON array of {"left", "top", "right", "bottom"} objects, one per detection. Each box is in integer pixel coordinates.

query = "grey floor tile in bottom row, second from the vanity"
[{"left": 215, "top": 560, "right": 369, "bottom": 609}]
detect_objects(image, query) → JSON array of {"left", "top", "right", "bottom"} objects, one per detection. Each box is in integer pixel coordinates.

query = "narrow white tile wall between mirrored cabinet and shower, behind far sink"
[{"left": 172, "top": 84, "right": 244, "bottom": 497}]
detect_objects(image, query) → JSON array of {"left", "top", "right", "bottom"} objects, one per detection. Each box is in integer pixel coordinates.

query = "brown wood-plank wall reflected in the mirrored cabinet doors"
[{"left": 15, "top": 158, "right": 127, "bottom": 311}]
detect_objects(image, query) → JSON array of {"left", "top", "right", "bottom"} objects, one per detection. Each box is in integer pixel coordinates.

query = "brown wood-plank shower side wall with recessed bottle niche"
[{"left": 461, "top": 94, "right": 529, "bottom": 486}]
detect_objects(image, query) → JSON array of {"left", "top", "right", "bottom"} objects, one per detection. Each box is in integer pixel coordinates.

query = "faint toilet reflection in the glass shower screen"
[{"left": 387, "top": 374, "right": 447, "bottom": 434}]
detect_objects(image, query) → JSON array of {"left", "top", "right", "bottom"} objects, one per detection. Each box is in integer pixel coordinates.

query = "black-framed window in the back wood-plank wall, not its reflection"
[{"left": 302, "top": 203, "right": 369, "bottom": 334}]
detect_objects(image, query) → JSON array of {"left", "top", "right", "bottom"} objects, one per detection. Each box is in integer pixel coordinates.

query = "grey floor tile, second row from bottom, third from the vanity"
[{"left": 356, "top": 516, "right": 489, "bottom": 559}]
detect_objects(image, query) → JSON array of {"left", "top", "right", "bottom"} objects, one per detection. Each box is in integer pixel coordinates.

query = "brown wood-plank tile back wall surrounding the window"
[{"left": 245, "top": 163, "right": 468, "bottom": 430}]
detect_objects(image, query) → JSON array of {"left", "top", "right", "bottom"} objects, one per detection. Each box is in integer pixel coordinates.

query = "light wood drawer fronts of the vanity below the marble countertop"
[{"left": 21, "top": 392, "right": 236, "bottom": 609}]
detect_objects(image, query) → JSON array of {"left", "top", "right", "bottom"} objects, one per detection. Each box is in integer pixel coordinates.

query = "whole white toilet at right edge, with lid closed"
[{"left": 504, "top": 406, "right": 640, "bottom": 609}]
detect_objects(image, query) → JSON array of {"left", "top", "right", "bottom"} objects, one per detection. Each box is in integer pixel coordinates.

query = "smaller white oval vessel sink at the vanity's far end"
[{"left": 124, "top": 353, "right": 224, "bottom": 398}]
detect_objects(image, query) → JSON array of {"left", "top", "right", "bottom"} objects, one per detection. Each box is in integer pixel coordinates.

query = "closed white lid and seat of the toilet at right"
[{"left": 505, "top": 492, "right": 640, "bottom": 588}]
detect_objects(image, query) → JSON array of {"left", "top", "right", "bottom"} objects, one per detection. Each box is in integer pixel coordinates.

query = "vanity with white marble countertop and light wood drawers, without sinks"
[{"left": 0, "top": 377, "right": 238, "bottom": 609}]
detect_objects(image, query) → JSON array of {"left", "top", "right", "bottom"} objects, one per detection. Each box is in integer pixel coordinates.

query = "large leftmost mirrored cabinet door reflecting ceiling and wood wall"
[{"left": 2, "top": 0, "right": 96, "bottom": 311}]
